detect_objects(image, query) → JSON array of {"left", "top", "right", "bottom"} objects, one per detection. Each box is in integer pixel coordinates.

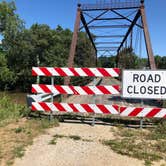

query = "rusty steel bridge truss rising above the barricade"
[{"left": 66, "top": 0, "right": 156, "bottom": 83}]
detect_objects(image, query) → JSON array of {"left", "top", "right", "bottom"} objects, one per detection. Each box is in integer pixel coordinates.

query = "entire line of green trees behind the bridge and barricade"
[{"left": 0, "top": 1, "right": 166, "bottom": 91}]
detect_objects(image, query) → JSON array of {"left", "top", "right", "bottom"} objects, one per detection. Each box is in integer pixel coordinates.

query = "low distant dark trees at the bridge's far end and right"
[{"left": 98, "top": 47, "right": 166, "bottom": 69}]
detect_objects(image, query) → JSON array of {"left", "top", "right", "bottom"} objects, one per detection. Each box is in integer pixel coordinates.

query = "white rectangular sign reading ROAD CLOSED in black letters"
[{"left": 122, "top": 70, "right": 166, "bottom": 99}]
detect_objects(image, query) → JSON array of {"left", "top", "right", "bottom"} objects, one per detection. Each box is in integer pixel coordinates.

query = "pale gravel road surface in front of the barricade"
[{"left": 14, "top": 123, "right": 147, "bottom": 166}]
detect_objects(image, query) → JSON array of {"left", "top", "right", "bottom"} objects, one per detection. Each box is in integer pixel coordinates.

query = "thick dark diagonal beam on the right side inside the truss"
[{"left": 117, "top": 10, "right": 141, "bottom": 52}]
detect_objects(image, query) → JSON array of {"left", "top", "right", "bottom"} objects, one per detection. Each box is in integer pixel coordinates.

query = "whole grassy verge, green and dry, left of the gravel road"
[{"left": 0, "top": 94, "right": 58, "bottom": 165}]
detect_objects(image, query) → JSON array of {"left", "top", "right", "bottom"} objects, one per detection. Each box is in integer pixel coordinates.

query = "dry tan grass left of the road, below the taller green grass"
[{"left": 0, "top": 119, "right": 58, "bottom": 166}]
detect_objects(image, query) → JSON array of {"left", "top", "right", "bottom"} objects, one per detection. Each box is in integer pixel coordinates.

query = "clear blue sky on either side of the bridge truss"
[{"left": 0, "top": 0, "right": 166, "bottom": 56}]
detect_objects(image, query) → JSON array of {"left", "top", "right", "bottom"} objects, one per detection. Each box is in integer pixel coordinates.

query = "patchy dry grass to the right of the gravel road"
[{"left": 102, "top": 122, "right": 166, "bottom": 166}]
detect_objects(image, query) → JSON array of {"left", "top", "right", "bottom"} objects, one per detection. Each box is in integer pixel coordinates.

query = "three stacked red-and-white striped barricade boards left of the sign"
[{"left": 31, "top": 67, "right": 120, "bottom": 115}]
